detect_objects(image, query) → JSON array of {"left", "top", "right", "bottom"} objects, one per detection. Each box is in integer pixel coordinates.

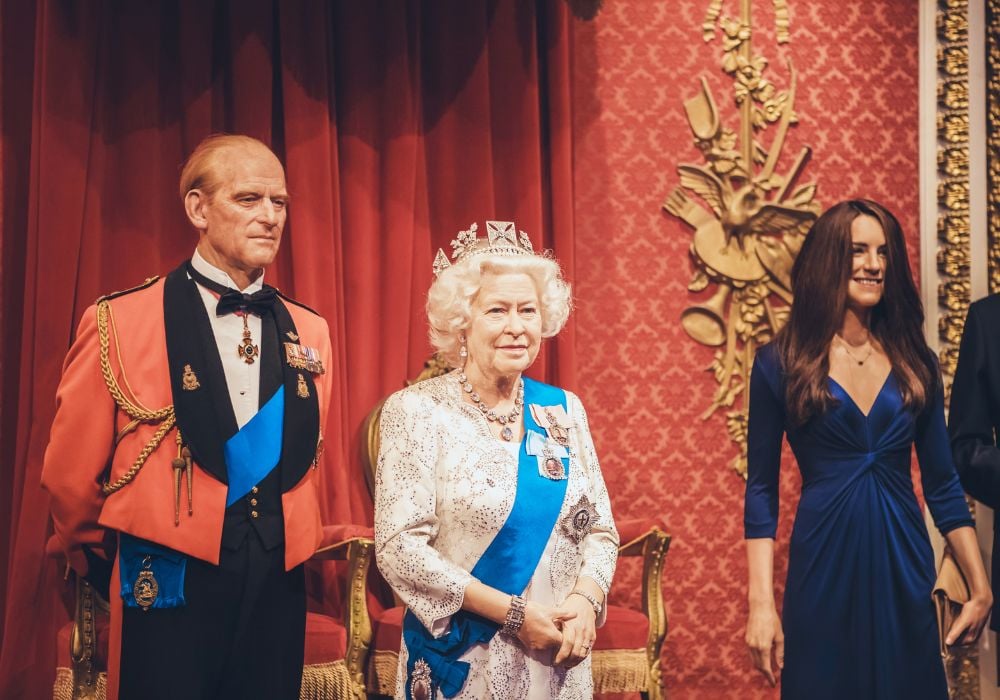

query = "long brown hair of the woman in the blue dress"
[{"left": 775, "top": 199, "right": 938, "bottom": 426}]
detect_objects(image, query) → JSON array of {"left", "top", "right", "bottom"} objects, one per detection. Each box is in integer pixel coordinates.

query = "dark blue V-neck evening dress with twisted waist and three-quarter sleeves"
[{"left": 744, "top": 344, "right": 972, "bottom": 700}]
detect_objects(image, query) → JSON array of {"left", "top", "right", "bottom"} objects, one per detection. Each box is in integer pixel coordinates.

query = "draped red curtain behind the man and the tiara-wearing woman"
[{"left": 0, "top": 0, "right": 574, "bottom": 698}]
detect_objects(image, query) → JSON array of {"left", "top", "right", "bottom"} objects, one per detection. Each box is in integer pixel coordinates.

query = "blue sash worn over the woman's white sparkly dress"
[{"left": 403, "top": 377, "right": 569, "bottom": 700}]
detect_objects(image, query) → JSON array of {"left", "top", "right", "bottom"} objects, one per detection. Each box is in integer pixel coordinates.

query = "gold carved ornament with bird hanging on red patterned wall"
[{"left": 663, "top": 0, "right": 820, "bottom": 478}]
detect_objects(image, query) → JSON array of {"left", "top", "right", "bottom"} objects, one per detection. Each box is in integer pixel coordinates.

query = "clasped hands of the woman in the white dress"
[{"left": 517, "top": 596, "right": 597, "bottom": 668}]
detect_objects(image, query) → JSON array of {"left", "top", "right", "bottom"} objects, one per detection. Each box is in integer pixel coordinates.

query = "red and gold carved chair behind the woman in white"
[{"left": 362, "top": 356, "right": 670, "bottom": 700}]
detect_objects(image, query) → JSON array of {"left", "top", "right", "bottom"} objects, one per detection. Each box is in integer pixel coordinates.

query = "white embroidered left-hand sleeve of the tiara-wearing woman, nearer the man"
[{"left": 375, "top": 390, "right": 473, "bottom": 636}]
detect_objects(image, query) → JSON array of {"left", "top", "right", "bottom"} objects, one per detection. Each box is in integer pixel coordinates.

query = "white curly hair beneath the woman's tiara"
[{"left": 427, "top": 254, "right": 572, "bottom": 367}]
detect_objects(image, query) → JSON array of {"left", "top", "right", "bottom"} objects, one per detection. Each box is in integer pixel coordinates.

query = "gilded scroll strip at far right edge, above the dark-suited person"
[{"left": 986, "top": 0, "right": 1000, "bottom": 293}]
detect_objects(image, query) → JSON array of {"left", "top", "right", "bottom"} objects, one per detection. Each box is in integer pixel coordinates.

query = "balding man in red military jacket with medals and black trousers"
[{"left": 42, "top": 136, "right": 330, "bottom": 699}]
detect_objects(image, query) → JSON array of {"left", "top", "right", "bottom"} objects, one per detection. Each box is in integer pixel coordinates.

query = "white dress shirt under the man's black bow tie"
[{"left": 191, "top": 249, "right": 264, "bottom": 428}]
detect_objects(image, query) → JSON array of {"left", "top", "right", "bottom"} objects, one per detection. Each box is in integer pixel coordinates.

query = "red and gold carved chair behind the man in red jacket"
[{"left": 46, "top": 525, "right": 374, "bottom": 700}]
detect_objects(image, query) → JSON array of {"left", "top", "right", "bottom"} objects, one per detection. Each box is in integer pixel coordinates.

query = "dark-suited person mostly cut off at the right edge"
[{"left": 948, "top": 294, "right": 1000, "bottom": 631}]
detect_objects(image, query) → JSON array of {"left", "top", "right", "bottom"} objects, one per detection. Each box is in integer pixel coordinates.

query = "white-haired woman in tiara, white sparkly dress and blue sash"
[{"left": 375, "top": 221, "right": 618, "bottom": 700}]
